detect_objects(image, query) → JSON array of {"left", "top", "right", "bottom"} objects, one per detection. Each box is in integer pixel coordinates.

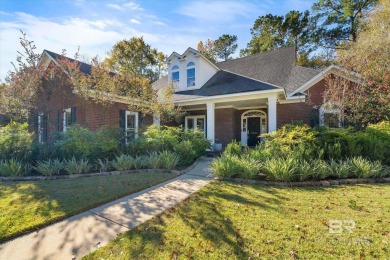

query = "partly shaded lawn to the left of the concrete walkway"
[{"left": 0, "top": 173, "right": 175, "bottom": 242}]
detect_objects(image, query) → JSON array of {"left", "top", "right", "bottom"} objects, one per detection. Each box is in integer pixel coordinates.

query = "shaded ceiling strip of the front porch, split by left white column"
[{"left": 182, "top": 98, "right": 268, "bottom": 110}]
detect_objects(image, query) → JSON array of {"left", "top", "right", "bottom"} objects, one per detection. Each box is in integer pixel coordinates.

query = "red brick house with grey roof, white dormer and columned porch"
[{"left": 37, "top": 47, "right": 354, "bottom": 147}]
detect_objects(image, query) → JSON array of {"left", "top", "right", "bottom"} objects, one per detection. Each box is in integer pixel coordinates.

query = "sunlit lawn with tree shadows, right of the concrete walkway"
[{"left": 85, "top": 182, "right": 390, "bottom": 259}]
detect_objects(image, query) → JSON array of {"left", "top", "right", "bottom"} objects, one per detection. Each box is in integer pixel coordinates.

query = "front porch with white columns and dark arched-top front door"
[{"left": 182, "top": 95, "right": 277, "bottom": 149}]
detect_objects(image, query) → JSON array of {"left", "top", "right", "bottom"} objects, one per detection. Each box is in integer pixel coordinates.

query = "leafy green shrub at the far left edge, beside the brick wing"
[{"left": 0, "top": 122, "right": 34, "bottom": 162}]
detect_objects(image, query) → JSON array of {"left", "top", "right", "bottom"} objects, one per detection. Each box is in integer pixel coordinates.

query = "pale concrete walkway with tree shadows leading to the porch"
[{"left": 0, "top": 158, "right": 212, "bottom": 260}]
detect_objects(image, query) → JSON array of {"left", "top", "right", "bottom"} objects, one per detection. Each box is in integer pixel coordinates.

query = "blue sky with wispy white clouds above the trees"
[{"left": 0, "top": 0, "right": 315, "bottom": 80}]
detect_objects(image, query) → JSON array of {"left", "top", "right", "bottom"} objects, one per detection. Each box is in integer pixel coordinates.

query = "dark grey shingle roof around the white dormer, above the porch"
[{"left": 153, "top": 47, "right": 321, "bottom": 100}]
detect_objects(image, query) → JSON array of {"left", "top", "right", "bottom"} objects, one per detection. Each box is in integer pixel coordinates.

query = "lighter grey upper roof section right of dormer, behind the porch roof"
[{"left": 216, "top": 47, "right": 321, "bottom": 94}]
